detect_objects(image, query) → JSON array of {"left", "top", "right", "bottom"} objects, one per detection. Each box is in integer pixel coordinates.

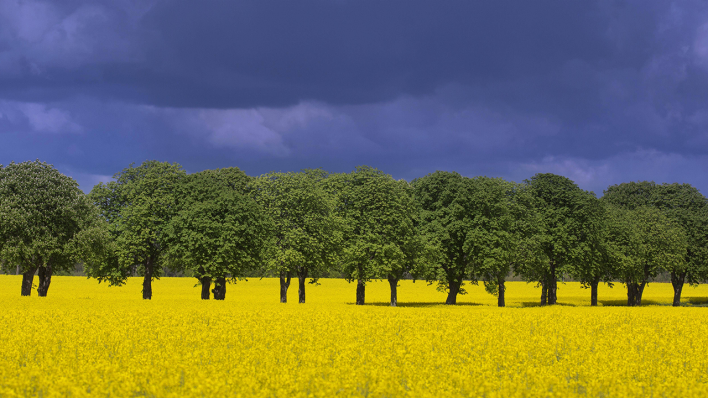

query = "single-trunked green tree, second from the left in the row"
[{"left": 89, "top": 160, "right": 186, "bottom": 300}]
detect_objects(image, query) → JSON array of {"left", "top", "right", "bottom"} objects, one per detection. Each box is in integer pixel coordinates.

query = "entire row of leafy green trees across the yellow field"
[{"left": 0, "top": 161, "right": 708, "bottom": 306}]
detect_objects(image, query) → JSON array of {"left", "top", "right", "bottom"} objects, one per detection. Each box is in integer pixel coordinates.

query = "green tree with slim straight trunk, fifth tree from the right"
[{"left": 465, "top": 177, "right": 538, "bottom": 307}]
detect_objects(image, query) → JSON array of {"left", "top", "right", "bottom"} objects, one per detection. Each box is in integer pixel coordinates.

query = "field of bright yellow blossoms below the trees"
[{"left": 0, "top": 276, "right": 708, "bottom": 397}]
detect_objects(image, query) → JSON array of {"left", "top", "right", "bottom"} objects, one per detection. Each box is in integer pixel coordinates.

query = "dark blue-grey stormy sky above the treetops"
[{"left": 0, "top": 0, "right": 708, "bottom": 196}]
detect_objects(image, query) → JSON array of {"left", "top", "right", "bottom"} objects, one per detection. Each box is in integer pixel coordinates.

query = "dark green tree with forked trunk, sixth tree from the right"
[{"left": 411, "top": 171, "right": 477, "bottom": 304}]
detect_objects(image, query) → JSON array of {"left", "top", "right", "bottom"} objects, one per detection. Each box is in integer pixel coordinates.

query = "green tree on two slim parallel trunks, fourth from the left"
[{"left": 252, "top": 169, "right": 342, "bottom": 303}]
